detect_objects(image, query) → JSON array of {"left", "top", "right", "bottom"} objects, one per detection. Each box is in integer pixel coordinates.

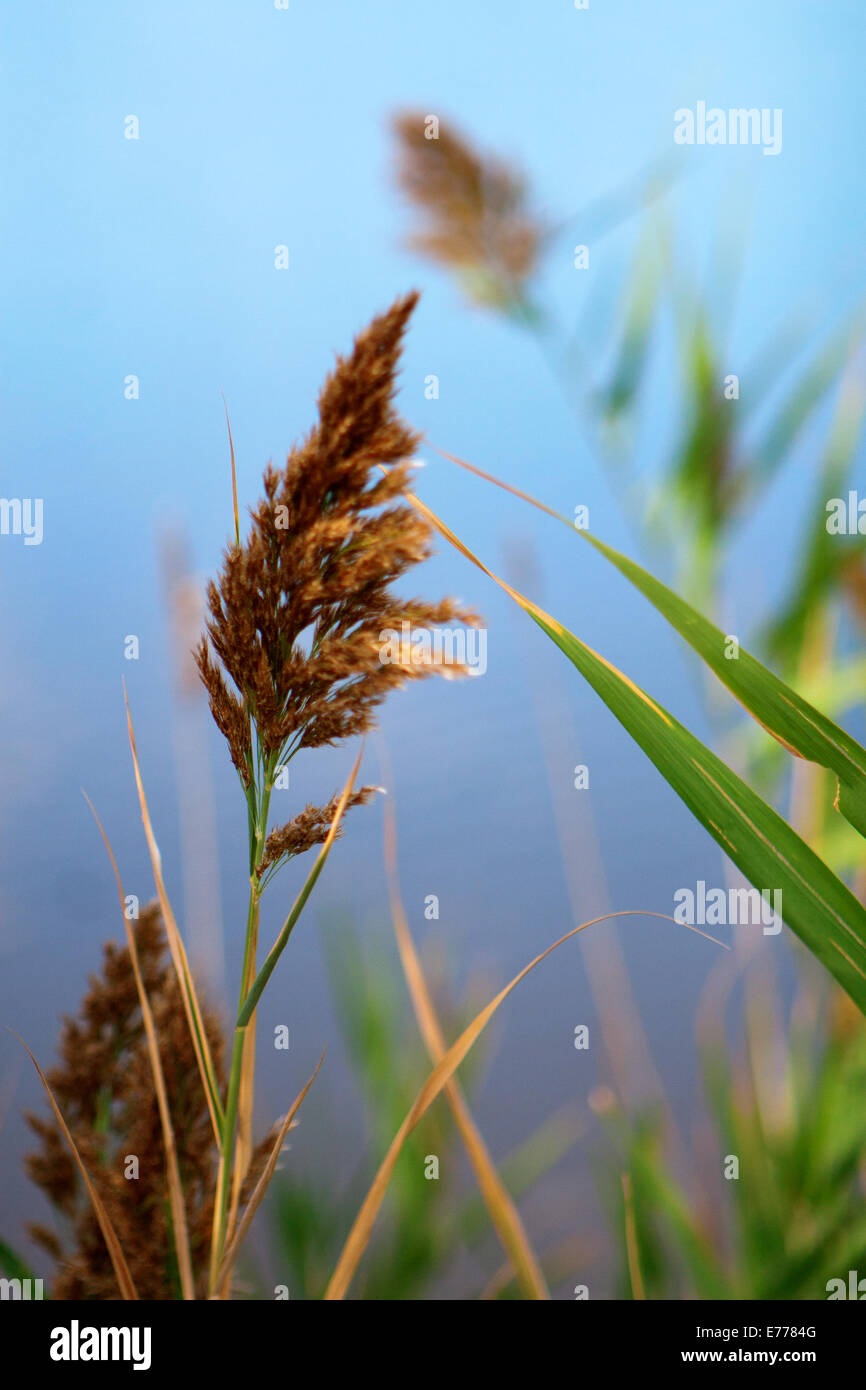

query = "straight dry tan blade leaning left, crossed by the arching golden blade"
[{"left": 385, "top": 778, "right": 550, "bottom": 1298}]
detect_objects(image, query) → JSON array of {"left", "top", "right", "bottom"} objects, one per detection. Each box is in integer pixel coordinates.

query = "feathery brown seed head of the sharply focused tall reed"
[{"left": 196, "top": 293, "right": 478, "bottom": 863}]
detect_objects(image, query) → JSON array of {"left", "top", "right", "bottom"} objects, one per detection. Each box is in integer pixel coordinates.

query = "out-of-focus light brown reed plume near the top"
[{"left": 395, "top": 111, "right": 544, "bottom": 307}]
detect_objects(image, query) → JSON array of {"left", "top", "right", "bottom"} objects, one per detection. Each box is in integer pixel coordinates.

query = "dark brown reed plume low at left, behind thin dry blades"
[{"left": 26, "top": 904, "right": 224, "bottom": 1300}]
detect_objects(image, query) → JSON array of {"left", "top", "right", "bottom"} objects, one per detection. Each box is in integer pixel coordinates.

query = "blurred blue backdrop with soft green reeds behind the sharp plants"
[{"left": 0, "top": 0, "right": 866, "bottom": 1297}]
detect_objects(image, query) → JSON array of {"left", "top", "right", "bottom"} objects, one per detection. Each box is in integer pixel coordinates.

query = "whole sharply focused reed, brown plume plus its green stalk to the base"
[{"left": 196, "top": 295, "right": 475, "bottom": 1295}]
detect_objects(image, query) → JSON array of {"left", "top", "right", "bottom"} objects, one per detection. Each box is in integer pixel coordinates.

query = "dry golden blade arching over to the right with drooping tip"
[{"left": 325, "top": 908, "right": 727, "bottom": 1301}]
